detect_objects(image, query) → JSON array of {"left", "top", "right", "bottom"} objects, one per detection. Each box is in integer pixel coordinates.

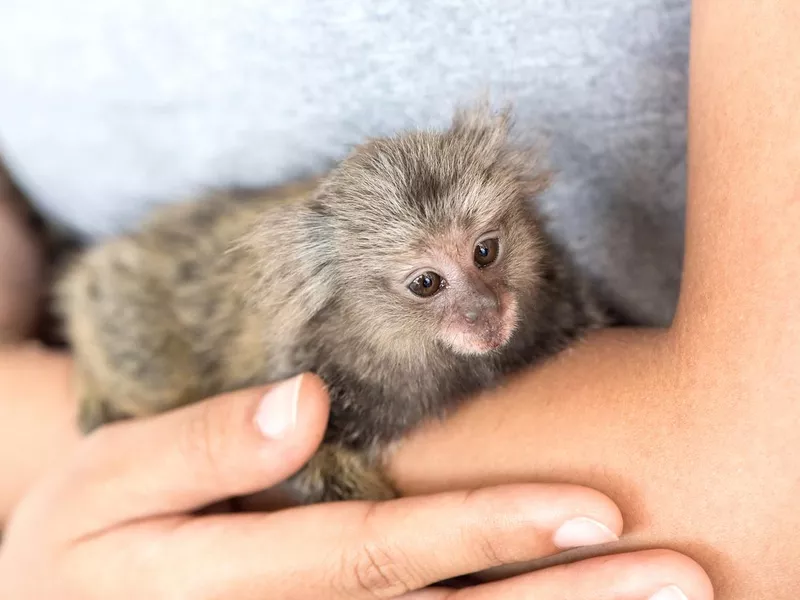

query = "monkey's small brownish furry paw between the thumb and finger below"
[{"left": 288, "top": 444, "right": 398, "bottom": 504}]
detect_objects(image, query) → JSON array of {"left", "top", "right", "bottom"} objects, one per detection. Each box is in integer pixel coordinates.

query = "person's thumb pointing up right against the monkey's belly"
[{"left": 52, "top": 375, "right": 328, "bottom": 535}]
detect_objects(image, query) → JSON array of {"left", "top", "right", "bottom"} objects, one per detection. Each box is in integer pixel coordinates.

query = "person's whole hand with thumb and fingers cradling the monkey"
[{"left": 0, "top": 376, "right": 711, "bottom": 600}]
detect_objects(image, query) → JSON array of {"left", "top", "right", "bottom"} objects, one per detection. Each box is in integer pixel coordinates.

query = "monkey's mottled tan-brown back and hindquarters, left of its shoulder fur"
[{"left": 58, "top": 182, "right": 313, "bottom": 431}]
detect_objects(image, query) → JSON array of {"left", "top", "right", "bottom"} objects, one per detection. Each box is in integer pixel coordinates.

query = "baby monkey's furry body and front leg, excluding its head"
[{"left": 61, "top": 106, "right": 603, "bottom": 502}]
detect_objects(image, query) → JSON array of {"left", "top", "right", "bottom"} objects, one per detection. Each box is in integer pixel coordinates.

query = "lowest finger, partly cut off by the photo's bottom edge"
[{"left": 404, "top": 550, "right": 714, "bottom": 600}]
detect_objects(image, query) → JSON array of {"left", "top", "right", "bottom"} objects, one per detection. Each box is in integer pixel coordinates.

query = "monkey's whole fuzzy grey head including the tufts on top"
[{"left": 311, "top": 109, "right": 547, "bottom": 355}]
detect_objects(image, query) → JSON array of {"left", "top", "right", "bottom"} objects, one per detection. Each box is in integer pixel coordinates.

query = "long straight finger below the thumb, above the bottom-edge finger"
[{"left": 153, "top": 484, "right": 622, "bottom": 599}]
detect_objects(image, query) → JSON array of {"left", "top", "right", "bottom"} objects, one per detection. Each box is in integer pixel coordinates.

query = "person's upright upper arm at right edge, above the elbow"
[{"left": 678, "top": 0, "right": 800, "bottom": 344}]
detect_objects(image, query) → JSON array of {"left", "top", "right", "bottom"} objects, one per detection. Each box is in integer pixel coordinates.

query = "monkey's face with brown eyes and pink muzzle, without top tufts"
[{"left": 328, "top": 159, "right": 542, "bottom": 356}]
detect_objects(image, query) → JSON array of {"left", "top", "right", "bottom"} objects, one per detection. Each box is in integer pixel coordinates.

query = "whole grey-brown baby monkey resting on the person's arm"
[{"left": 60, "top": 106, "right": 605, "bottom": 502}]
